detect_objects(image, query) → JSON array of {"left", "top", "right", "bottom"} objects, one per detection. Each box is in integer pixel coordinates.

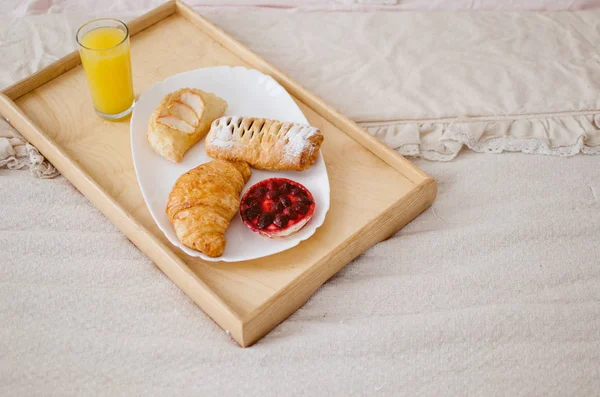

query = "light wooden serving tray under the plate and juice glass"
[{"left": 0, "top": 1, "right": 437, "bottom": 346}]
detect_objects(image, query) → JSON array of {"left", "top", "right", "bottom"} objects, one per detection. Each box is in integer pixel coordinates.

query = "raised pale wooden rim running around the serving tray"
[{"left": 0, "top": 0, "right": 437, "bottom": 347}]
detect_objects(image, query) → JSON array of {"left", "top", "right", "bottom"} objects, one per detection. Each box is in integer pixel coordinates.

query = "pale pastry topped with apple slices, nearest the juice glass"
[{"left": 146, "top": 88, "right": 227, "bottom": 163}]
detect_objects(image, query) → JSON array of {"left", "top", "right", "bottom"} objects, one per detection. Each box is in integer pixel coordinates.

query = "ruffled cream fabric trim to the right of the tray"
[{"left": 361, "top": 113, "right": 600, "bottom": 161}]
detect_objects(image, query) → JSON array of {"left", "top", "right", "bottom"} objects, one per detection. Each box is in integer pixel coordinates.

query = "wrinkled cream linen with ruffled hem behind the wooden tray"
[{"left": 0, "top": 8, "right": 600, "bottom": 166}]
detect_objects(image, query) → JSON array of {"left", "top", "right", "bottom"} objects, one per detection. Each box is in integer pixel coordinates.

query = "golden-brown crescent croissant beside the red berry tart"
[{"left": 166, "top": 160, "right": 251, "bottom": 257}]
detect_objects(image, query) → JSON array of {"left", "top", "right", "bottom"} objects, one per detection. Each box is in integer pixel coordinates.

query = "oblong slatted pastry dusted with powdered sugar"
[{"left": 205, "top": 117, "right": 323, "bottom": 171}]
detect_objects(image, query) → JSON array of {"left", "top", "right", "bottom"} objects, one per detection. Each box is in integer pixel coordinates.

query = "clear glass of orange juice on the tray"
[{"left": 77, "top": 18, "right": 134, "bottom": 120}]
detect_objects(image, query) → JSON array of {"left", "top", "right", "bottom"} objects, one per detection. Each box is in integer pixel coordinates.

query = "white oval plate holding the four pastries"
[{"left": 131, "top": 66, "right": 329, "bottom": 262}]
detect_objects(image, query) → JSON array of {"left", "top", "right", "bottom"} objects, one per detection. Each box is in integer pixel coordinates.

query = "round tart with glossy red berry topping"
[{"left": 240, "top": 178, "right": 315, "bottom": 238}]
